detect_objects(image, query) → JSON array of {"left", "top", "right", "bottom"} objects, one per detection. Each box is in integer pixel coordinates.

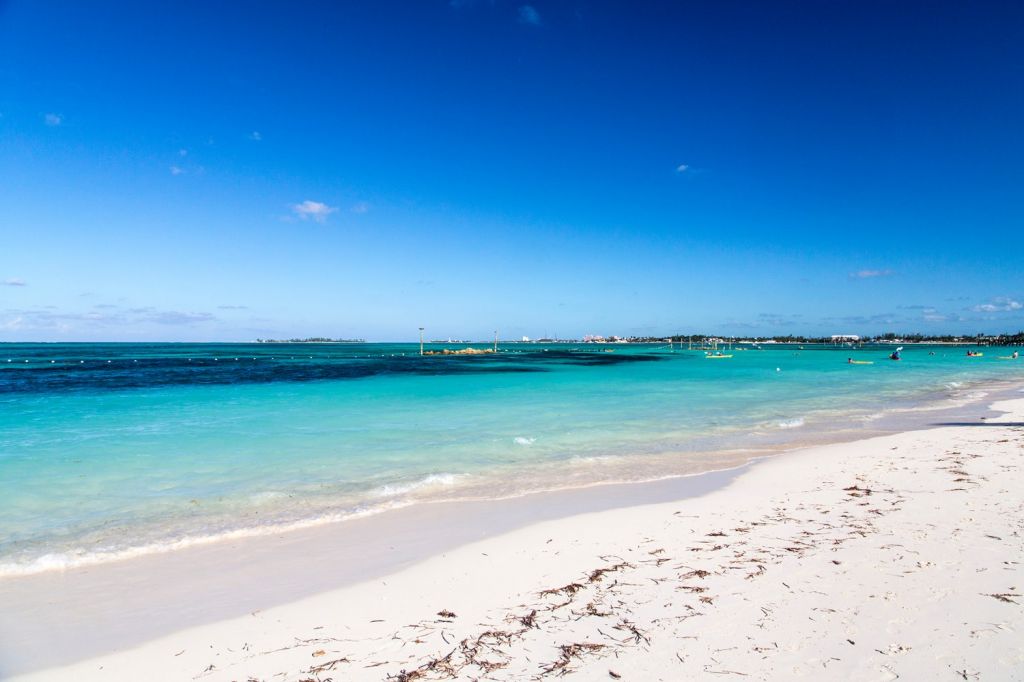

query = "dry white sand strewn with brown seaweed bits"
[{"left": 13, "top": 399, "right": 1024, "bottom": 682}]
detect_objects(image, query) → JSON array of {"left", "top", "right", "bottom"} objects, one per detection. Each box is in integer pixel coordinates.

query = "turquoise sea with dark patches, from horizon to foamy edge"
[{"left": 0, "top": 344, "right": 1024, "bottom": 577}]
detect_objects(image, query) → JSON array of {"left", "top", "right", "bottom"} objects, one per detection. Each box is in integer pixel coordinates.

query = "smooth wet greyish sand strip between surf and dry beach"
[{"left": 0, "top": 389, "right": 1024, "bottom": 679}]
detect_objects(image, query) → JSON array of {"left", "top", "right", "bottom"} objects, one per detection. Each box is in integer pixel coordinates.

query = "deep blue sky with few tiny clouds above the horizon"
[{"left": 0, "top": 0, "right": 1024, "bottom": 340}]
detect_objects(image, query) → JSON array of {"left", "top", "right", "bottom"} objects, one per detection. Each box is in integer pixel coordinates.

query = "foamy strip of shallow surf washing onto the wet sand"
[{"left": 0, "top": 372, "right": 1019, "bottom": 587}]
